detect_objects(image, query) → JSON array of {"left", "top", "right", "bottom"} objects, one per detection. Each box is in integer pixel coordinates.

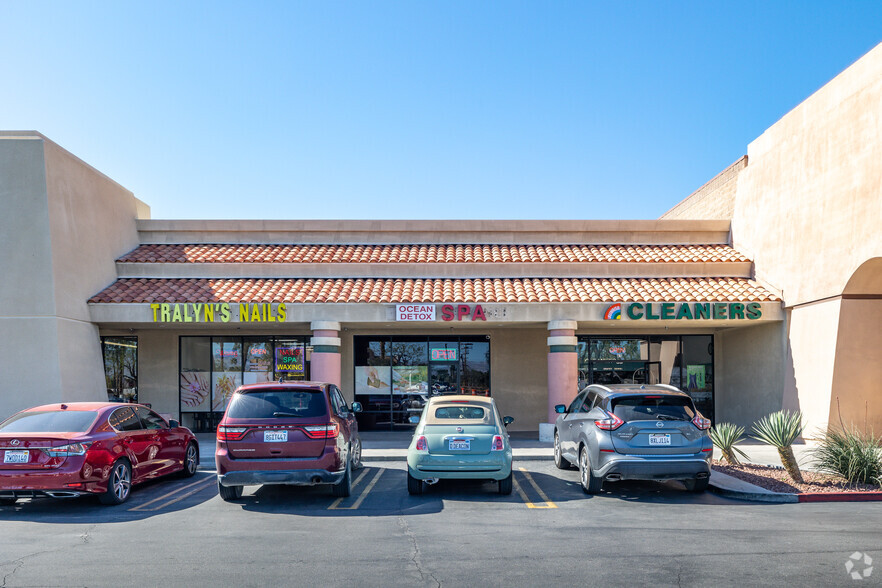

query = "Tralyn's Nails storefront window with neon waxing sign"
[{"left": 179, "top": 337, "right": 310, "bottom": 431}]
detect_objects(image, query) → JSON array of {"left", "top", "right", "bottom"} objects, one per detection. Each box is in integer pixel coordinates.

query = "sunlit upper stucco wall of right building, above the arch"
[{"left": 732, "top": 45, "right": 882, "bottom": 306}]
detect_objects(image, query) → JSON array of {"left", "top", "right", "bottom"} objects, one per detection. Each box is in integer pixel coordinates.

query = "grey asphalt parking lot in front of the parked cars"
[{"left": 0, "top": 460, "right": 882, "bottom": 586}]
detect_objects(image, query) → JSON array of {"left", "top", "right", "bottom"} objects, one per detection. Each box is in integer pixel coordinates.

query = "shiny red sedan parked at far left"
[{"left": 0, "top": 402, "right": 199, "bottom": 505}]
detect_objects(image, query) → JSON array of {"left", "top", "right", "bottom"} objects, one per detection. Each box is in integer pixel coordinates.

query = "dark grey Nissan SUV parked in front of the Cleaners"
[{"left": 554, "top": 384, "right": 714, "bottom": 494}]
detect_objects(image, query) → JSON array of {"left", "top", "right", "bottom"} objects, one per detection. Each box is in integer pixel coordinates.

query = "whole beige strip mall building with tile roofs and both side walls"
[{"left": 0, "top": 46, "right": 882, "bottom": 432}]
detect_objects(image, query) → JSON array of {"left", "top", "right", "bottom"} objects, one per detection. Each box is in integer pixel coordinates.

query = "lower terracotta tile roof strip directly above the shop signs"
[{"left": 89, "top": 278, "right": 780, "bottom": 303}]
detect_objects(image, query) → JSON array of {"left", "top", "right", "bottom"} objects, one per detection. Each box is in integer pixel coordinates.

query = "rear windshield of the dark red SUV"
[{"left": 227, "top": 389, "right": 328, "bottom": 419}]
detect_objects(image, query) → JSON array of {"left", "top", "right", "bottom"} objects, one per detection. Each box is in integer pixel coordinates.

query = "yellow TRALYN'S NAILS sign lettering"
[{"left": 150, "top": 302, "right": 288, "bottom": 323}]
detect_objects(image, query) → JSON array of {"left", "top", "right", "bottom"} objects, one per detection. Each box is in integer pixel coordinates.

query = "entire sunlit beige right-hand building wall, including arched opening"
[{"left": 662, "top": 45, "right": 882, "bottom": 435}]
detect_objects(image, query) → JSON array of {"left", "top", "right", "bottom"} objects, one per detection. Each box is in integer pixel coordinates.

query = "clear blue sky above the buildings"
[{"left": 0, "top": 0, "right": 882, "bottom": 219}]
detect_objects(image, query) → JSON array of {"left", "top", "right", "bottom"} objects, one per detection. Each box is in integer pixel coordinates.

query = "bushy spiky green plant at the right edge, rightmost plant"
[{"left": 811, "top": 428, "right": 882, "bottom": 485}]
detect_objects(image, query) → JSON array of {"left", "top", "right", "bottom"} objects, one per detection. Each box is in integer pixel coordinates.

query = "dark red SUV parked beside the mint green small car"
[{"left": 215, "top": 382, "right": 361, "bottom": 501}]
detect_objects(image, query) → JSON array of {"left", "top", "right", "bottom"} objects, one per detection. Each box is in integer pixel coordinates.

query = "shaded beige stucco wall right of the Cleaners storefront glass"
[{"left": 714, "top": 323, "right": 785, "bottom": 432}]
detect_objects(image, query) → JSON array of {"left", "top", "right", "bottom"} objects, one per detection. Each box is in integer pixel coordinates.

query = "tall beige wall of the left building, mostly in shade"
[{"left": 0, "top": 131, "right": 149, "bottom": 417}]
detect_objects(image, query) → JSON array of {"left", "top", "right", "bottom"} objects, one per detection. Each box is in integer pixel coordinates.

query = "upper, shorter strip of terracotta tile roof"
[{"left": 118, "top": 244, "right": 750, "bottom": 263}]
